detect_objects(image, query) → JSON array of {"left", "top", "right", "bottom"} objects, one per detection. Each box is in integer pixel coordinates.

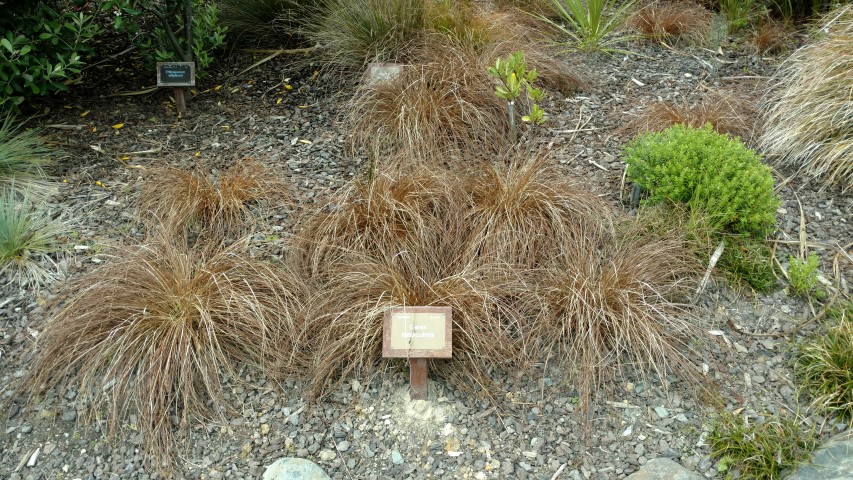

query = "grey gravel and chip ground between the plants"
[{"left": 0, "top": 29, "right": 853, "bottom": 480}]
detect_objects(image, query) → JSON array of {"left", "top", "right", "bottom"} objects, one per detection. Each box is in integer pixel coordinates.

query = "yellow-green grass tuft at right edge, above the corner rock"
[{"left": 794, "top": 301, "right": 853, "bottom": 422}]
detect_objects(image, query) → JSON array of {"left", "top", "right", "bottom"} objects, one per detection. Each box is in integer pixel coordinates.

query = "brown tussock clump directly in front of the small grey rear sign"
[{"left": 350, "top": 44, "right": 509, "bottom": 162}]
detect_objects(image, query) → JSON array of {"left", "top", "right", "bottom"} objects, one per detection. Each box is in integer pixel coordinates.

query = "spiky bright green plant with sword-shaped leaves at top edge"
[{"left": 539, "top": 0, "right": 637, "bottom": 53}]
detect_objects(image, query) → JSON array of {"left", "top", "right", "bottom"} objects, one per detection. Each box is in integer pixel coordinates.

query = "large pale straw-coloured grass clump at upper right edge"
[{"left": 760, "top": 5, "right": 853, "bottom": 190}]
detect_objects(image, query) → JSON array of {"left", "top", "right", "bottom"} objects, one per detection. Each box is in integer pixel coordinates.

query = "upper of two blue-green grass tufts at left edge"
[{"left": 0, "top": 115, "right": 52, "bottom": 198}]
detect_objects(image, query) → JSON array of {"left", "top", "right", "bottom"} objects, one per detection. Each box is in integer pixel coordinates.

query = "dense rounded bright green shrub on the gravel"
[{"left": 625, "top": 125, "right": 779, "bottom": 238}]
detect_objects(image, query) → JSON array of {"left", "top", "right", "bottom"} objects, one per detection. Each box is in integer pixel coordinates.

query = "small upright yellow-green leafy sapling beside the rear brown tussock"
[{"left": 488, "top": 51, "right": 545, "bottom": 144}]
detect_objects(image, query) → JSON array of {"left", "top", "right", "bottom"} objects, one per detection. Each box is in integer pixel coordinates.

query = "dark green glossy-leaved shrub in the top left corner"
[{"left": 0, "top": 2, "right": 100, "bottom": 109}]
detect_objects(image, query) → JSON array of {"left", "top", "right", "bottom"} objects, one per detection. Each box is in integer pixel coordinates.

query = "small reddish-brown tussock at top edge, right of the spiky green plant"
[{"left": 628, "top": 1, "right": 712, "bottom": 43}]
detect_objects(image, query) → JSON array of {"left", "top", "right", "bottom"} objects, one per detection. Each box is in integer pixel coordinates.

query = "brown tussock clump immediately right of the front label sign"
[{"left": 526, "top": 216, "right": 699, "bottom": 406}]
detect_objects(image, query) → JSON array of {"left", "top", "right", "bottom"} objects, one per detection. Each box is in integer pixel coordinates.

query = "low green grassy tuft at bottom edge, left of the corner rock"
[{"left": 707, "top": 413, "right": 817, "bottom": 480}]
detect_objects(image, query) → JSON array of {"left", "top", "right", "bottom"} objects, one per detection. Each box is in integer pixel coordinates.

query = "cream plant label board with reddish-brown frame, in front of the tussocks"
[{"left": 382, "top": 307, "right": 453, "bottom": 358}]
